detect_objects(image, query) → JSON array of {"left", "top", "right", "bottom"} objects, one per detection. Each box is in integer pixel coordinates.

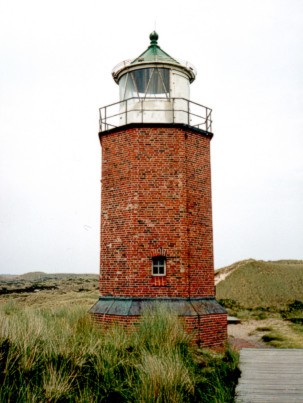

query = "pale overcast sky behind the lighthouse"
[{"left": 0, "top": 0, "right": 303, "bottom": 274}]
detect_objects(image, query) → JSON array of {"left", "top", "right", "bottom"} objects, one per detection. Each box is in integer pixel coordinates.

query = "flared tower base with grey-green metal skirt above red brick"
[{"left": 90, "top": 297, "right": 227, "bottom": 348}]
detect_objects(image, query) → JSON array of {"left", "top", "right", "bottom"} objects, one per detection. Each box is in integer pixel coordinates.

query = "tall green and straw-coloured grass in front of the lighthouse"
[{"left": 0, "top": 291, "right": 239, "bottom": 403}]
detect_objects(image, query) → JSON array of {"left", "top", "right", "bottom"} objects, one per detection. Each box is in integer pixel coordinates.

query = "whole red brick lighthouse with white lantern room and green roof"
[{"left": 90, "top": 32, "right": 227, "bottom": 347}]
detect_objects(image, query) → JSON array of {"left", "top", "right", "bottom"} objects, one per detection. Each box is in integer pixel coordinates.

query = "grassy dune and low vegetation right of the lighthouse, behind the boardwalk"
[{"left": 217, "top": 259, "right": 303, "bottom": 348}]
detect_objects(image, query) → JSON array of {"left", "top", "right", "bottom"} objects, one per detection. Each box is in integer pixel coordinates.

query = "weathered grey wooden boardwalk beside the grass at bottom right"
[{"left": 235, "top": 348, "right": 303, "bottom": 403}]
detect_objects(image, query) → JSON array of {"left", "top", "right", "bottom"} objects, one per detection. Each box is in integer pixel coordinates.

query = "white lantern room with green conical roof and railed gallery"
[{"left": 100, "top": 31, "right": 211, "bottom": 131}]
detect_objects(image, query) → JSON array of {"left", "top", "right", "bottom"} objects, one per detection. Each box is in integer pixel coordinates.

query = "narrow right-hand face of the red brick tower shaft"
[{"left": 186, "top": 133, "right": 214, "bottom": 297}]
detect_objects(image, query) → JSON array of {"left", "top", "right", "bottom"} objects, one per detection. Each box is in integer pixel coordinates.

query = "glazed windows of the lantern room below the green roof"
[{"left": 119, "top": 67, "right": 170, "bottom": 100}]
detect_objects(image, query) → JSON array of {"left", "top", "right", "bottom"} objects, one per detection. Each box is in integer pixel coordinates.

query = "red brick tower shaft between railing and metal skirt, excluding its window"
[{"left": 100, "top": 126, "right": 214, "bottom": 297}]
